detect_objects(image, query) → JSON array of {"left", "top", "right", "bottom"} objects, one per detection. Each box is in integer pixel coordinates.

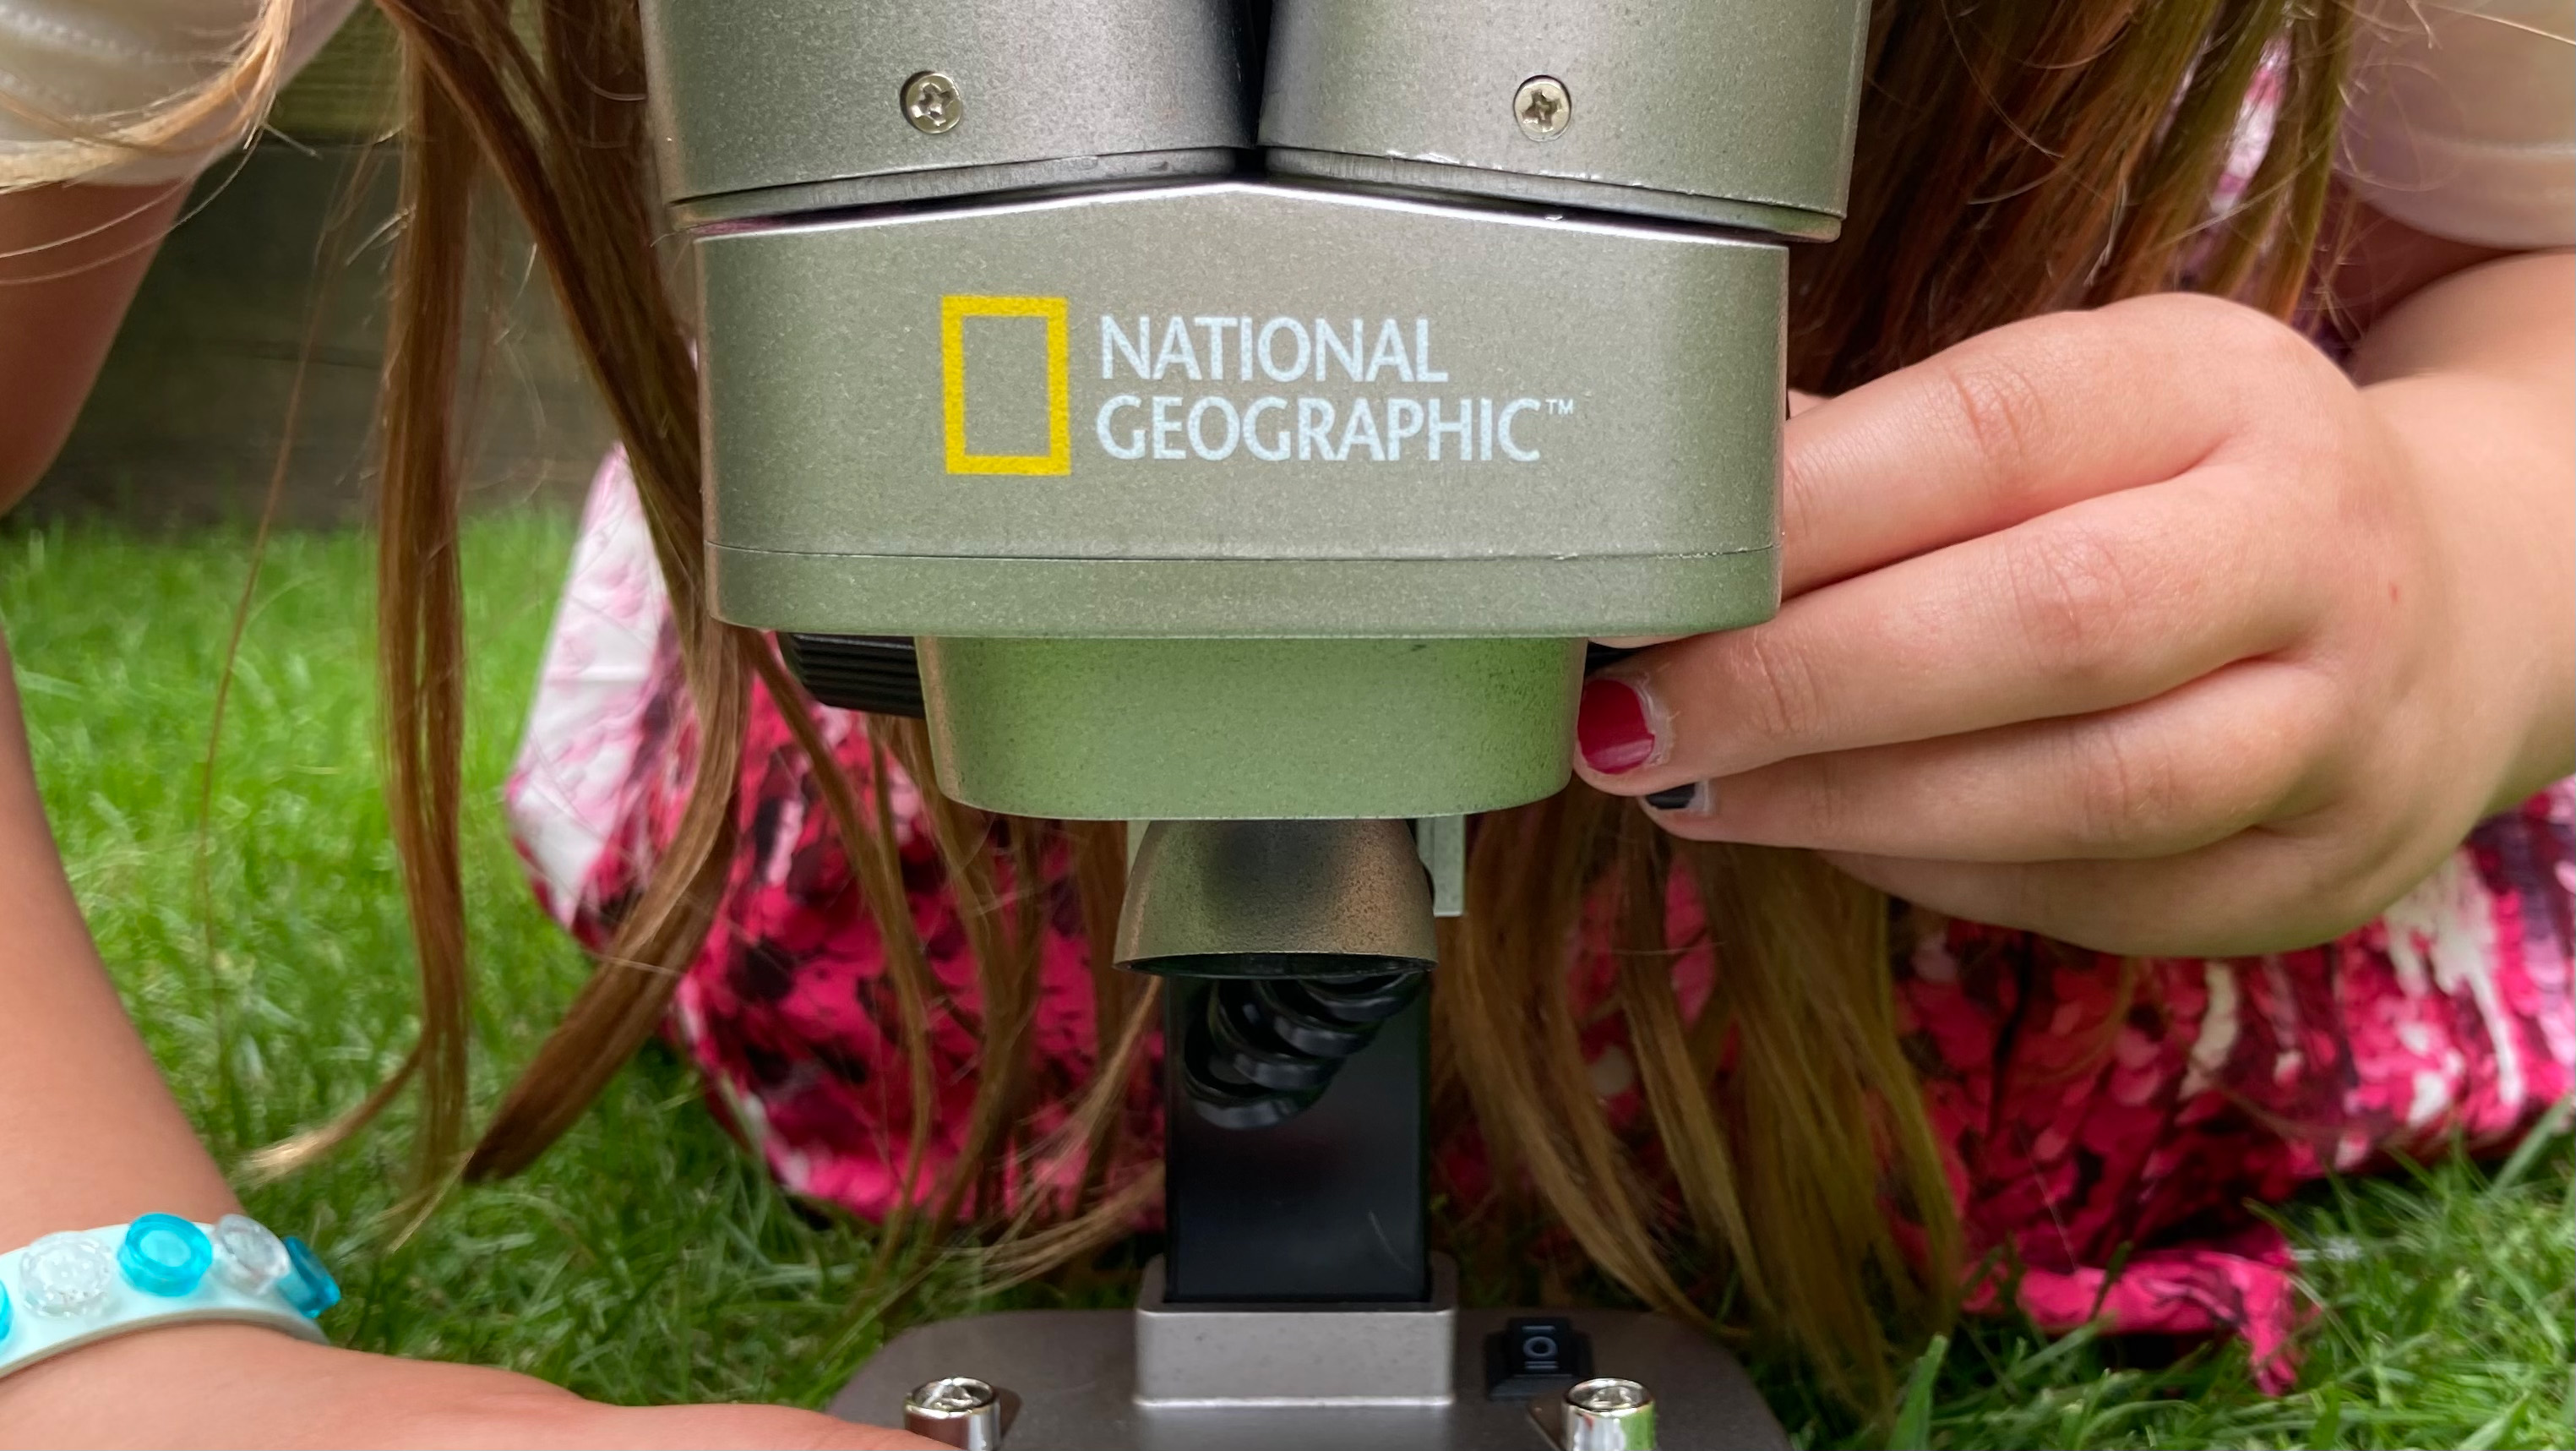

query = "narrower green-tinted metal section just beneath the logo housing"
[{"left": 923, "top": 639, "right": 1582, "bottom": 824}]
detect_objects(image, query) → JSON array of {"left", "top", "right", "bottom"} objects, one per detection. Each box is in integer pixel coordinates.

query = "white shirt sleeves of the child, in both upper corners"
[{"left": 0, "top": 0, "right": 2576, "bottom": 248}]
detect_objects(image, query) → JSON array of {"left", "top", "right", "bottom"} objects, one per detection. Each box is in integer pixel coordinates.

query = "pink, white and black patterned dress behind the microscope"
[{"left": 508, "top": 456, "right": 2576, "bottom": 1384}]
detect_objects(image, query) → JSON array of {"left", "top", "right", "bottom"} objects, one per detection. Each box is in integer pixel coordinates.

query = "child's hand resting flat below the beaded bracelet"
[{"left": 0, "top": 1325, "right": 935, "bottom": 1451}]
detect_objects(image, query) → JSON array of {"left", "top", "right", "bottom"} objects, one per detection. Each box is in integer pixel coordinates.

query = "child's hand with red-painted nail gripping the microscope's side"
[{"left": 1582, "top": 297, "right": 2563, "bottom": 953}]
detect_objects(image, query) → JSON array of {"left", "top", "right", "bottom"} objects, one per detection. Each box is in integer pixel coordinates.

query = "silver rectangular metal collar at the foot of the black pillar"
[{"left": 1136, "top": 1255, "right": 1458, "bottom": 1410}]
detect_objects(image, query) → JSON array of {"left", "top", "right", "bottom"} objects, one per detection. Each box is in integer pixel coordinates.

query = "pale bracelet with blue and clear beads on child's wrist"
[{"left": 0, "top": 1214, "right": 340, "bottom": 1377}]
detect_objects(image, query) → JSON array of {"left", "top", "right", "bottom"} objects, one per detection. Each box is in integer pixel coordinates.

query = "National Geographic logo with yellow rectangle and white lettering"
[{"left": 940, "top": 297, "right": 1574, "bottom": 474}]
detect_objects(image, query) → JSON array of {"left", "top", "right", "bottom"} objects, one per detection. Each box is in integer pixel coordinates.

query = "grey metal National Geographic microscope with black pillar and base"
[{"left": 644, "top": 0, "right": 1868, "bottom": 1451}]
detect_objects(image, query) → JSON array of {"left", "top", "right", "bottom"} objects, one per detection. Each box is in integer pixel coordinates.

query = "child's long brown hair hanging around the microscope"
[{"left": 161, "top": 0, "right": 2352, "bottom": 1399}]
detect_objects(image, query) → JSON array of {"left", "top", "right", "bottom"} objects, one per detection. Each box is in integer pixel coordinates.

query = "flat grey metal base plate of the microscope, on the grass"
[{"left": 830, "top": 1309, "right": 1788, "bottom": 1451}]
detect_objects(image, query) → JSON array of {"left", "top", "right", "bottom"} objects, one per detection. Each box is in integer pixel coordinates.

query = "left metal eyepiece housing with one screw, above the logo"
[{"left": 644, "top": 0, "right": 1250, "bottom": 201}]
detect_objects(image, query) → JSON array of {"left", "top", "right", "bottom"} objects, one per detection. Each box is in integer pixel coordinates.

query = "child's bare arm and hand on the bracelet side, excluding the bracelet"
[{"left": 0, "top": 188, "right": 930, "bottom": 1446}]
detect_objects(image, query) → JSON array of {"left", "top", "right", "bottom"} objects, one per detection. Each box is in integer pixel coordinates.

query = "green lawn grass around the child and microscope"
[{"left": 0, "top": 515, "right": 2576, "bottom": 1446}]
